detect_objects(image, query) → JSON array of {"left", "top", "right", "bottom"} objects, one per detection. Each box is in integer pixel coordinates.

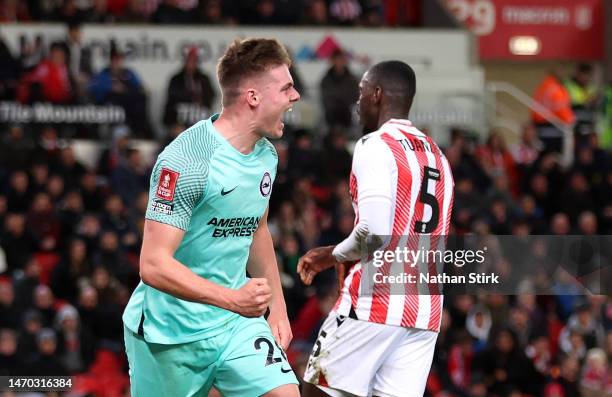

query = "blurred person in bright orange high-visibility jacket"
[{"left": 531, "top": 71, "right": 576, "bottom": 152}]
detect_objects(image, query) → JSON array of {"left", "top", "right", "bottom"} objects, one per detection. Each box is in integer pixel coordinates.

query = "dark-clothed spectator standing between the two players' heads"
[{"left": 320, "top": 49, "right": 359, "bottom": 128}]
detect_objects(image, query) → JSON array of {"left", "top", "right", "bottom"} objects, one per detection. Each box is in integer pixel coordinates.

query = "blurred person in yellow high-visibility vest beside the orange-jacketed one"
[{"left": 564, "top": 63, "right": 599, "bottom": 137}]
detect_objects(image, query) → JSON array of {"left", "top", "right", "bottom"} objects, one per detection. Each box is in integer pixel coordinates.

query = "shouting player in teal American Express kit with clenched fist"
[{"left": 123, "top": 39, "right": 300, "bottom": 397}]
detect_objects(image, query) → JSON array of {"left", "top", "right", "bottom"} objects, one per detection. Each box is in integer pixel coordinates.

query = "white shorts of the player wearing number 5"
[{"left": 304, "top": 313, "right": 438, "bottom": 397}]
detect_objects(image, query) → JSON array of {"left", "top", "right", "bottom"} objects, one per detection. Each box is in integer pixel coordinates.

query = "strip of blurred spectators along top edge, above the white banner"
[{"left": 0, "top": 0, "right": 421, "bottom": 26}]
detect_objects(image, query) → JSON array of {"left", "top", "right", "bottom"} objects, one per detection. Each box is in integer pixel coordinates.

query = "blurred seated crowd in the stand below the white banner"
[{"left": 0, "top": 84, "right": 612, "bottom": 397}]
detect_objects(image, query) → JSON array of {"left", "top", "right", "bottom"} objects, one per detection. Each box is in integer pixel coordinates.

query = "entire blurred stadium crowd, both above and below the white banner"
[{"left": 0, "top": 8, "right": 612, "bottom": 397}]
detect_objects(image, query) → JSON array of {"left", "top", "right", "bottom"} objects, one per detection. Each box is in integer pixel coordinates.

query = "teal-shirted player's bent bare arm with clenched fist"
[{"left": 140, "top": 220, "right": 272, "bottom": 317}]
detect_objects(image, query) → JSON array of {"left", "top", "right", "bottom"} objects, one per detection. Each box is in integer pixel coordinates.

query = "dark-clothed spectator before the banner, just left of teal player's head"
[{"left": 164, "top": 47, "right": 216, "bottom": 126}]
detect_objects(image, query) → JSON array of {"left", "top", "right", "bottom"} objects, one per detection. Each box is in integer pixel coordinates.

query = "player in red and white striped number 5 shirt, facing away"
[{"left": 298, "top": 61, "right": 454, "bottom": 397}]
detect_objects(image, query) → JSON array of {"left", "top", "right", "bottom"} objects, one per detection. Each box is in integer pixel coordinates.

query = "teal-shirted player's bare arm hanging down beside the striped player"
[{"left": 247, "top": 209, "right": 293, "bottom": 349}]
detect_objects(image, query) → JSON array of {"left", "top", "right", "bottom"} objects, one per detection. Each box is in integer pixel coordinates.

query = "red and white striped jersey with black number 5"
[{"left": 334, "top": 119, "right": 454, "bottom": 331}]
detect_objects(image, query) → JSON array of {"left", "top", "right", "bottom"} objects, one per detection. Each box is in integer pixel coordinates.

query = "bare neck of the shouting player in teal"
[{"left": 214, "top": 109, "right": 261, "bottom": 154}]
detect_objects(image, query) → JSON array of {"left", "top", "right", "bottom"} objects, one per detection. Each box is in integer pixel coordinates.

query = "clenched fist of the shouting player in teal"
[{"left": 230, "top": 278, "right": 272, "bottom": 317}]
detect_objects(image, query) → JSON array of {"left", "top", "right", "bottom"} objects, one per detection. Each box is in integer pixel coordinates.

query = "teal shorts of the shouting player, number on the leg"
[{"left": 124, "top": 317, "right": 298, "bottom": 397}]
